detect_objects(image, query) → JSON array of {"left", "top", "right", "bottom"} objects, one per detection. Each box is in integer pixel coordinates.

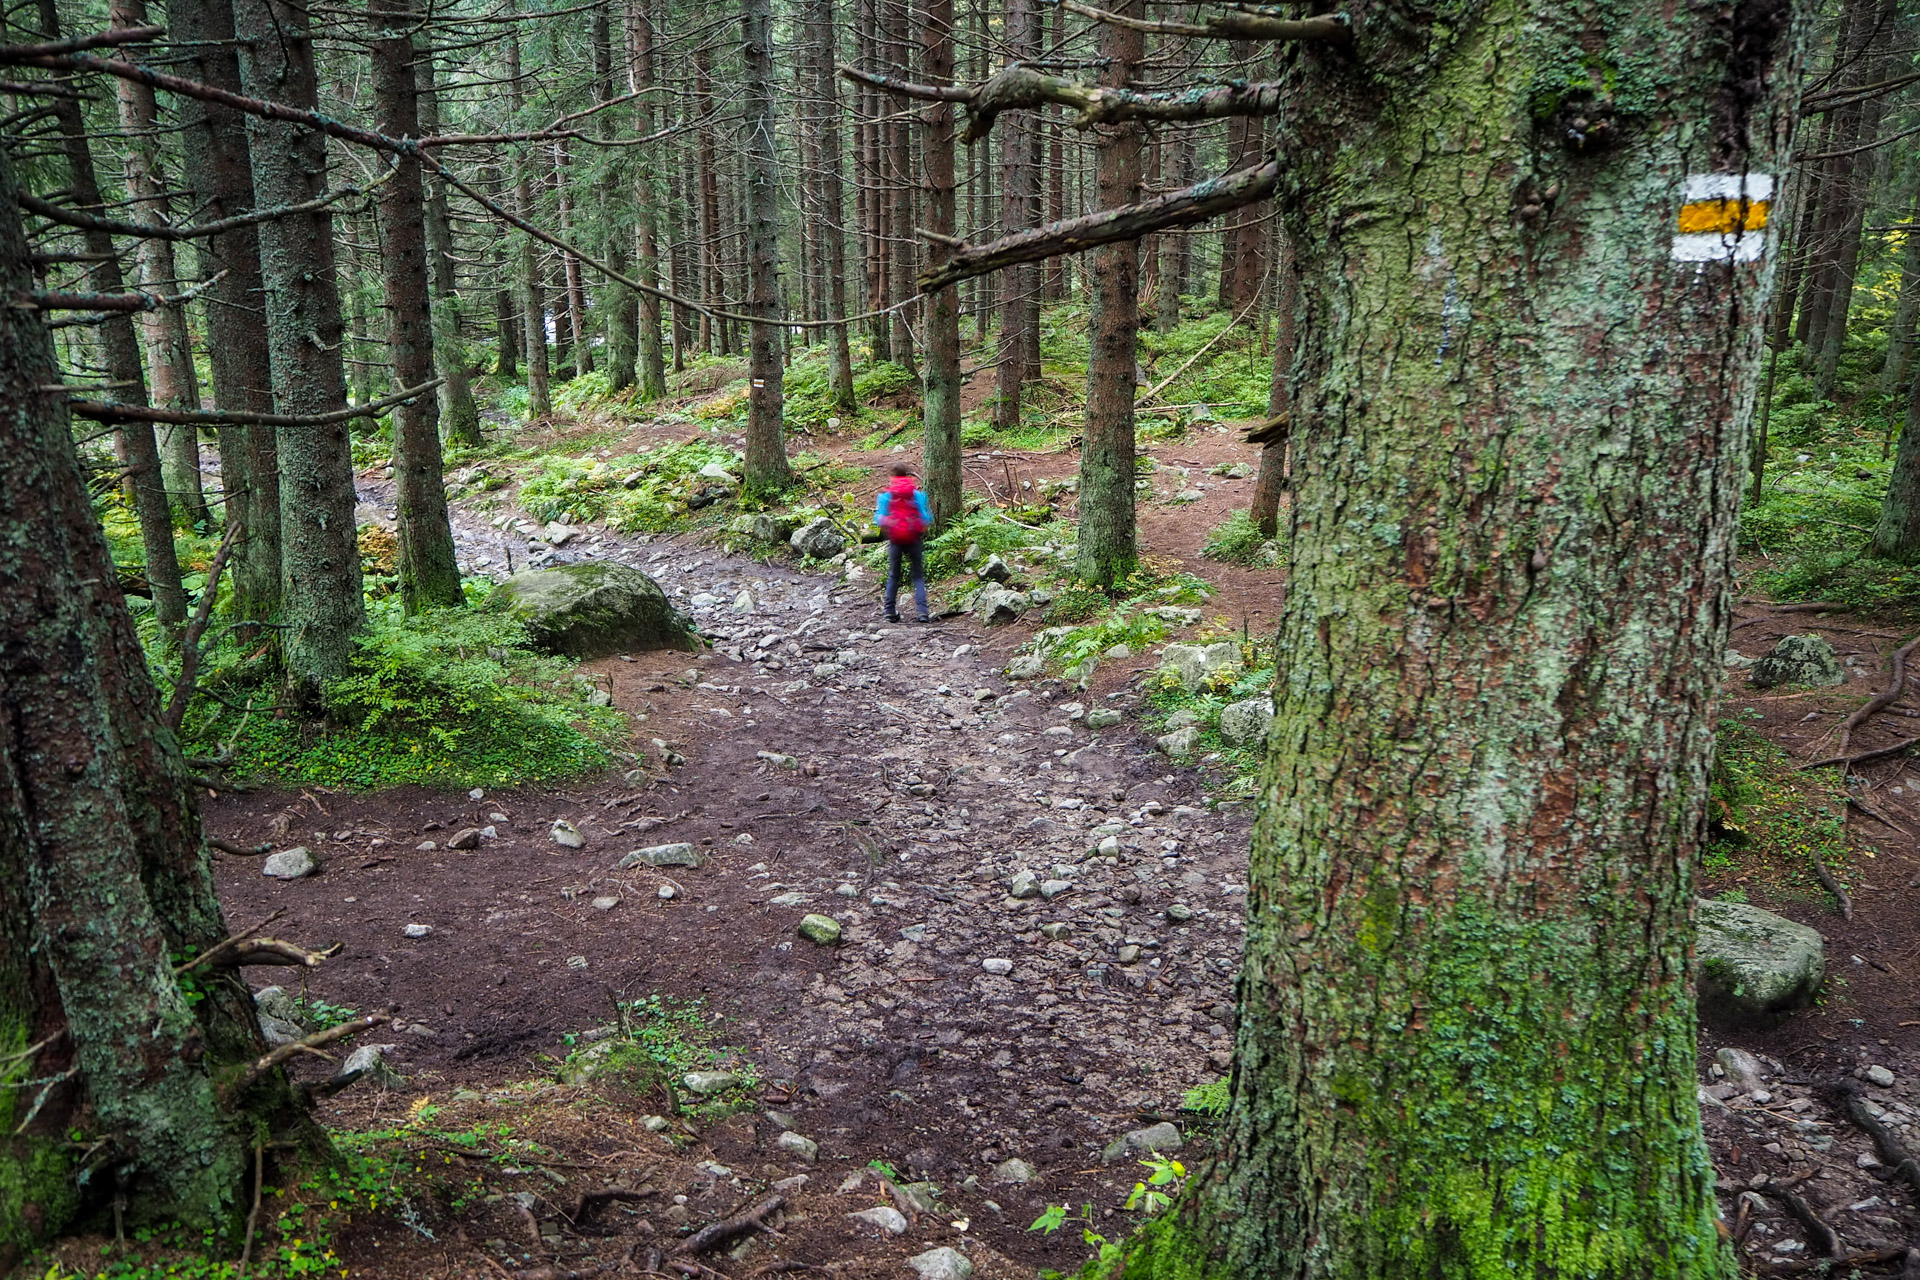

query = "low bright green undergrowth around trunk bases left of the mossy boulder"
[{"left": 184, "top": 597, "right": 624, "bottom": 789}]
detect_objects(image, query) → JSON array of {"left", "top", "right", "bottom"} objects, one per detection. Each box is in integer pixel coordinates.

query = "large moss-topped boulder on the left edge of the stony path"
[{"left": 480, "top": 560, "right": 699, "bottom": 658}]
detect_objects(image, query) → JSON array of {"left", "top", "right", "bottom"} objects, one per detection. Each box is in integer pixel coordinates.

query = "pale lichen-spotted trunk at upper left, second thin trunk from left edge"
[{"left": 108, "top": 0, "right": 213, "bottom": 530}]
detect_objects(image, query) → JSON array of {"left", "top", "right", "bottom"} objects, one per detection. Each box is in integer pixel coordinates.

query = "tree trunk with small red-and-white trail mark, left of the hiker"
[{"left": 739, "top": 0, "right": 793, "bottom": 495}]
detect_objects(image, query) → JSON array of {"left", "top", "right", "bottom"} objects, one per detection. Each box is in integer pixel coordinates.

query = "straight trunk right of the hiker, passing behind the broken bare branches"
[{"left": 1073, "top": 0, "right": 1146, "bottom": 587}]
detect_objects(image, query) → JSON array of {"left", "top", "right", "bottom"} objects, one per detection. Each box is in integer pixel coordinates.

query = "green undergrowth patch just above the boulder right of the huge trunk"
[{"left": 1701, "top": 712, "right": 1870, "bottom": 909}]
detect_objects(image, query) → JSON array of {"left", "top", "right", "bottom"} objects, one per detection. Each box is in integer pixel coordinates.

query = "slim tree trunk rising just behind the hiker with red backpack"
[{"left": 920, "top": 0, "right": 960, "bottom": 528}]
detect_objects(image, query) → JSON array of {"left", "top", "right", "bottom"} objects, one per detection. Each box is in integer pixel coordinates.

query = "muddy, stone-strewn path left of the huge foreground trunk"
[{"left": 205, "top": 482, "right": 1248, "bottom": 1274}]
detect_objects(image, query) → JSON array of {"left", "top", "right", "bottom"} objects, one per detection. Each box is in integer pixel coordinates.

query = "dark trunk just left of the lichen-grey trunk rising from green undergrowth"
[{"left": 167, "top": 0, "right": 280, "bottom": 620}]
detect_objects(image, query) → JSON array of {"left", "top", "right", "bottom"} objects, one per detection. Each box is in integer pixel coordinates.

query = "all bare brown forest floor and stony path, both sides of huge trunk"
[{"left": 41, "top": 395, "right": 1920, "bottom": 1280}]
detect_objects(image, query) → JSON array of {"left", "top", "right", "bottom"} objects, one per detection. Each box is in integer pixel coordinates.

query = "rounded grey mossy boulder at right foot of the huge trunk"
[{"left": 1695, "top": 898, "right": 1826, "bottom": 1025}]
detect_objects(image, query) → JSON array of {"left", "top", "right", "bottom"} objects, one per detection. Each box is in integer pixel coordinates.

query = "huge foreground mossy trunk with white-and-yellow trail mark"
[{"left": 1110, "top": 0, "right": 1799, "bottom": 1280}]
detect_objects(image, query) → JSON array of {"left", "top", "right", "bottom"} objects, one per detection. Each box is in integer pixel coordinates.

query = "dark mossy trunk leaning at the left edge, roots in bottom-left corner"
[{"left": 0, "top": 154, "right": 303, "bottom": 1268}]
